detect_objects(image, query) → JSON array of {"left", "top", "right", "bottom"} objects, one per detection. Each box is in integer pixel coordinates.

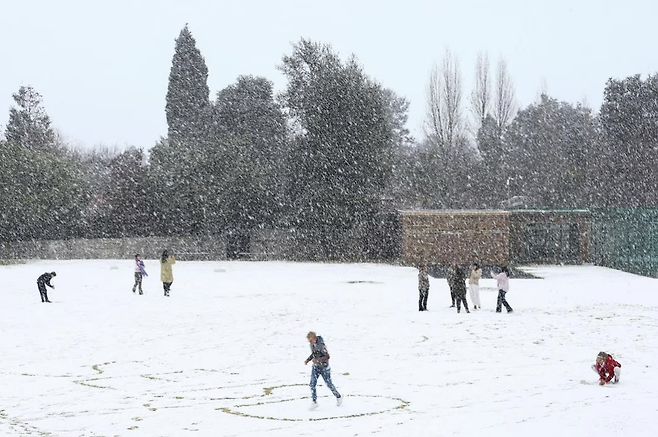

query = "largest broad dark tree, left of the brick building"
[{"left": 280, "top": 40, "right": 393, "bottom": 258}]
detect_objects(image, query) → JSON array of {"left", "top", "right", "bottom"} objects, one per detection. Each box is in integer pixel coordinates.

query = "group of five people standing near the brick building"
[{"left": 418, "top": 258, "right": 513, "bottom": 313}]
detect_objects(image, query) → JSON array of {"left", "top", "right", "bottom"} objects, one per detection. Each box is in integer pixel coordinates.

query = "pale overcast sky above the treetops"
[{"left": 0, "top": 0, "right": 658, "bottom": 148}]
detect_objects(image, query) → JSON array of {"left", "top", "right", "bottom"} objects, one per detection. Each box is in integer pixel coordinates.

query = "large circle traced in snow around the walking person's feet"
[{"left": 218, "top": 395, "right": 409, "bottom": 422}]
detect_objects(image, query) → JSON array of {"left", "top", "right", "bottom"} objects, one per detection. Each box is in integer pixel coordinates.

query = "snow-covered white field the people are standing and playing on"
[{"left": 0, "top": 260, "right": 658, "bottom": 437}]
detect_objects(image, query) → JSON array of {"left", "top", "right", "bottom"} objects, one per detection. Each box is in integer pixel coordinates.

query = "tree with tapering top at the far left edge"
[{"left": 0, "top": 87, "right": 90, "bottom": 240}]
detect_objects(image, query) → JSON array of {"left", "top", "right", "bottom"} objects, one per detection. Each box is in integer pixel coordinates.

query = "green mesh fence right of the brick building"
[{"left": 590, "top": 208, "right": 658, "bottom": 277}]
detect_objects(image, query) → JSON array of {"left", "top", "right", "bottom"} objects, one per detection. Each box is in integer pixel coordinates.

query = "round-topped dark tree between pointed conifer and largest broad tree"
[{"left": 214, "top": 76, "right": 287, "bottom": 238}]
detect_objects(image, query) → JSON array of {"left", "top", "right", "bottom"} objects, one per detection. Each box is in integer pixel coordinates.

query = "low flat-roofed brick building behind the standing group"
[{"left": 399, "top": 210, "right": 589, "bottom": 264}]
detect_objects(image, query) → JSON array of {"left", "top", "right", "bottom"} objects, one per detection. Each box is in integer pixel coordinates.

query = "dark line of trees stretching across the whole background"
[{"left": 0, "top": 27, "right": 658, "bottom": 258}]
